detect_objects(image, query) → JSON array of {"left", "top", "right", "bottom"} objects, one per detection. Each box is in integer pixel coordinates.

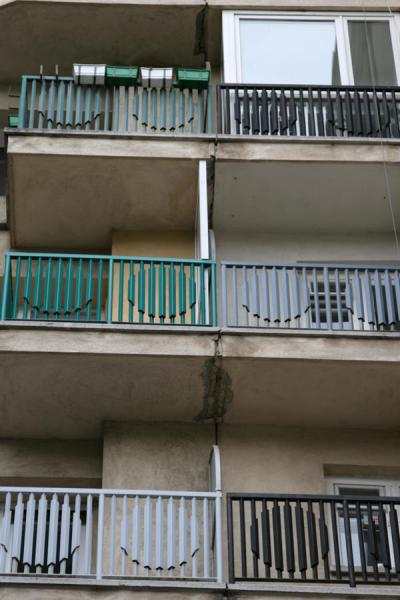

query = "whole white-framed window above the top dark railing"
[{"left": 223, "top": 11, "right": 400, "bottom": 86}]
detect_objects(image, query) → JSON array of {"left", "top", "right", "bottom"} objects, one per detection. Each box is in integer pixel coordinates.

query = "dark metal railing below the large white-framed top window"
[{"left": 217, "top": 83, "right": 400, "bottom": 138}]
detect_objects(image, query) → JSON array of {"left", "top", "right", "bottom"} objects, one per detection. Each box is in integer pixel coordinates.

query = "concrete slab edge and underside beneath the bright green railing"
[{"left": 0, "top": 327, "right": 219, "bottom": 439}]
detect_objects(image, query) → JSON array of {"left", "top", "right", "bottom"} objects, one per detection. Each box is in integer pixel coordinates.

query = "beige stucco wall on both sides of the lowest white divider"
[{"left": 103, "top": 422, "right": 400, "bottom": 494}]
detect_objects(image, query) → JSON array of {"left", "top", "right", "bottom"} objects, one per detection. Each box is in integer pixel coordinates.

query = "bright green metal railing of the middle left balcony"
[{"left": 1, "top": 252, "right": 217, "bottom": 326}]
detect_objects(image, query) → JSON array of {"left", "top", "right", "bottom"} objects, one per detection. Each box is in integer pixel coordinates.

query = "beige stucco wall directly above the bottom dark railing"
[{"left": 219, "top": 425, "right": 400, "bottom": 494}]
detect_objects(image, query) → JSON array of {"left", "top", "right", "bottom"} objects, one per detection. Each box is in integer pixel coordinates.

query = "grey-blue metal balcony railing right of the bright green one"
[{"left": 221, "top": 262, "right": 400, "bottom": 332}]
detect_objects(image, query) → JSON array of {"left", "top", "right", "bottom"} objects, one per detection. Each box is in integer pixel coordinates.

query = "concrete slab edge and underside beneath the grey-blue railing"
[{"left": 222, "top": 334, "right": 400, "bottom": 430}]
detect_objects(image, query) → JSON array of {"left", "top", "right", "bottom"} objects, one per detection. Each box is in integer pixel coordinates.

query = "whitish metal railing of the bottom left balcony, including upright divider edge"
[{"left": 0, "top": 447, "right": 223, "bottom": 582}]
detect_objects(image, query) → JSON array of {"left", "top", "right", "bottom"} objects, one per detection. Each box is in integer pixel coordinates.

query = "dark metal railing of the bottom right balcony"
[{"left": 227, "top": 493, "right": 400, "bottom": 586}]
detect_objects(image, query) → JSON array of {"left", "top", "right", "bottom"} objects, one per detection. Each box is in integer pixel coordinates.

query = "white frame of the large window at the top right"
[{"left": 222, "top": 11, "right": 400, "bottom": 86}]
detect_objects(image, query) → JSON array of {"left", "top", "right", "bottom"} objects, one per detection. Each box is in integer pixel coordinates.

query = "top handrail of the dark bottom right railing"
[{"left": 226, "top": 492, "right": 400, "bottom": 504}]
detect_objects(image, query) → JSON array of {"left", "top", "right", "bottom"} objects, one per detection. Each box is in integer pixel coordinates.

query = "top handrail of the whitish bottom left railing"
[{"left": 0, "top": 486, "right": 221, "bottom": 499}]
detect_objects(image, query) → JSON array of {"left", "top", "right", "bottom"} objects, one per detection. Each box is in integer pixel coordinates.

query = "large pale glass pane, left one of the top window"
[{"left": 240, "top": 19, "right": 340, "bottom": 85}]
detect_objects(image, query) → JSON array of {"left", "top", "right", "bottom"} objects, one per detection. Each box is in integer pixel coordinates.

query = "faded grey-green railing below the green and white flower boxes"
[{"left": 18, "top": 75, "right": 213, "bottom": 134}]
